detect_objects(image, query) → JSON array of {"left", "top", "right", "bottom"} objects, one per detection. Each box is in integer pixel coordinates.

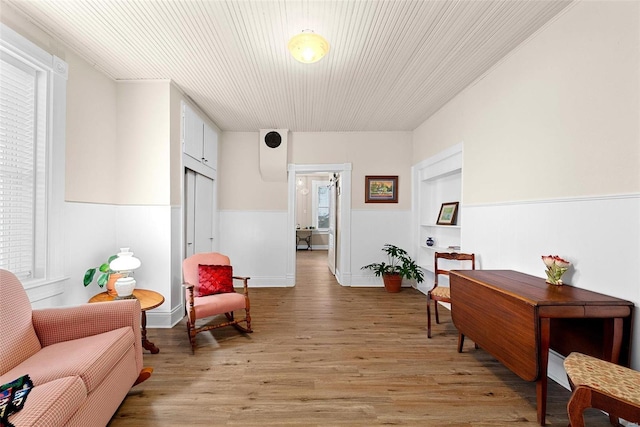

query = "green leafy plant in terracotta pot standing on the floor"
[{"left": 361, "top": 243, "right": 424, "bottom": 292}]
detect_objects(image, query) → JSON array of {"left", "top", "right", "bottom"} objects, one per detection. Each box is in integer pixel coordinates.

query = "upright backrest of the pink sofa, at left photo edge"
[{"left": 0, "top": 269, "right": 40, "bottom": 374}]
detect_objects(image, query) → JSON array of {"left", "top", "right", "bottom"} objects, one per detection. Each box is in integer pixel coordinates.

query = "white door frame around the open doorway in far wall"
[{"left": 287, "top": 163, "right": 351, "bottom": 286}]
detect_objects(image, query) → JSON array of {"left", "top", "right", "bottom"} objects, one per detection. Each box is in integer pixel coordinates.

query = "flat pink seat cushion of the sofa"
[{"left": 0, "top": 327, "right": 135, "bottom": 393}]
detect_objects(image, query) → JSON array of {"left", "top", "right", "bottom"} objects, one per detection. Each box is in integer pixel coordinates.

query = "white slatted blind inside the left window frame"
[{"left": 0, "top": 55, "right": 42, "bottom": 279}]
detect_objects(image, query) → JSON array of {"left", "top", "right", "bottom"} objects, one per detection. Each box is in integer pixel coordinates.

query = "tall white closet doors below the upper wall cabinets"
[{"left": 184, "top": 169, "right": 215, "bottom": 257}]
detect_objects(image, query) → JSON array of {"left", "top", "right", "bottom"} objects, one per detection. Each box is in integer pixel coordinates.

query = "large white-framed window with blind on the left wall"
[{"left": 0, "top": 24, "right": 67, "bottom": 283}]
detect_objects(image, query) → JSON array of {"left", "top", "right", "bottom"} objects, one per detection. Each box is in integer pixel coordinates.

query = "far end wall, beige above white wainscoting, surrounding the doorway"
[{"left": 219, "top": 132, "right": 411, "bottom": 286}]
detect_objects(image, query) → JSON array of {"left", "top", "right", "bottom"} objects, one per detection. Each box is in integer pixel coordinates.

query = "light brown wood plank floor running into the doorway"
[{"left": 109, "top": 251, "right": 609, "bottom": 427}]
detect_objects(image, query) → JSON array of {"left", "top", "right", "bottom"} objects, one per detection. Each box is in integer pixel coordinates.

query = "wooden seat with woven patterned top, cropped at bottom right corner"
[{"left": 564, "top": 352, "right": 640, "bottom": 427}]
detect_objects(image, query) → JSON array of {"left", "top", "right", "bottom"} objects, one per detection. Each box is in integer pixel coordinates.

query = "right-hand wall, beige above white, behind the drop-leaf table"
[{"left": 414, "top": 1, "right": 640, "bottom": 369}]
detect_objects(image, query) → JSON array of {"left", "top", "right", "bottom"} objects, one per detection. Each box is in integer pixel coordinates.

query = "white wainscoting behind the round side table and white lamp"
[{"left": 63, "top": 203, "right": 176, "bottom": 327}]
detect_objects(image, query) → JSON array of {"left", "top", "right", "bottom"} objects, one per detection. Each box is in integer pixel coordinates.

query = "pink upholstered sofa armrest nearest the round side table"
[{"left": 32, "top": 299, "right": 142, "bottom": 350}]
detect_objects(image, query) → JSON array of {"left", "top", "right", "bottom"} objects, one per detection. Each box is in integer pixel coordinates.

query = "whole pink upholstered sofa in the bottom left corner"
[{"left": 0, "top": 269, "right": 146, "bottom": 427}]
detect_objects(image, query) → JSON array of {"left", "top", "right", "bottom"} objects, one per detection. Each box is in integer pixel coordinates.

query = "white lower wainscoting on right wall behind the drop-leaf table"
[{"left": 462, "top": 194, "right": 640, "bottom": 383}]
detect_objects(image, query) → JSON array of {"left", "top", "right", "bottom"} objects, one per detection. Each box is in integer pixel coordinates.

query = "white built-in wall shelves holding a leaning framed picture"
[{"left": 412, "top": 143, "right": 464, "bottom": 291}]
